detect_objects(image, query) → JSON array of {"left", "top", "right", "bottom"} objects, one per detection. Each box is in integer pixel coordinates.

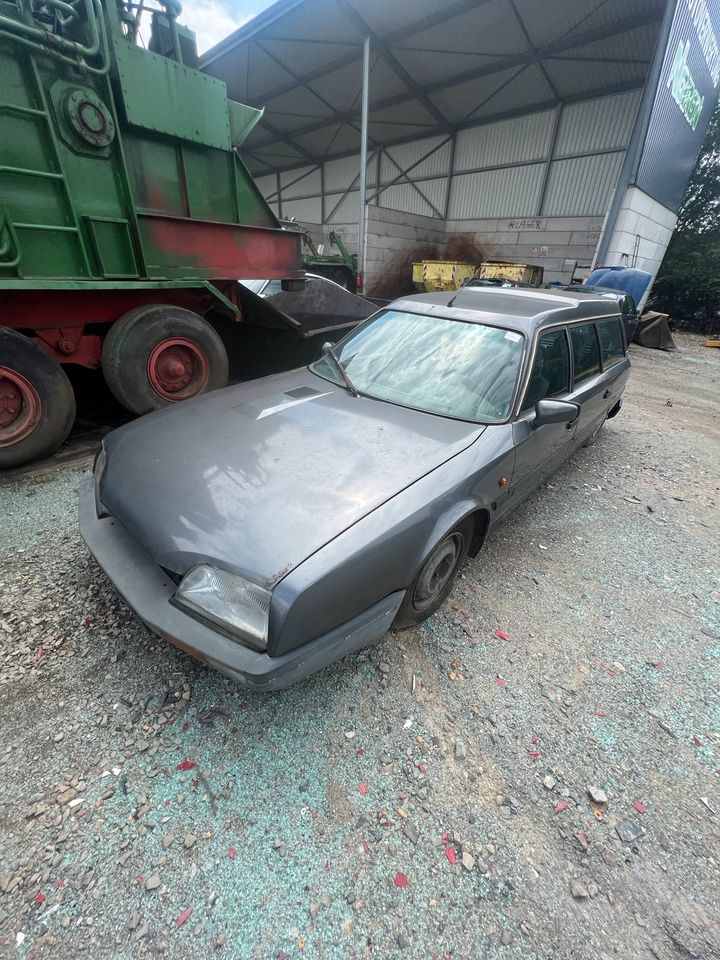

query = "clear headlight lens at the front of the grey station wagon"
[{"left": 175, "top": 564, "right": 271, "bottom": 650}]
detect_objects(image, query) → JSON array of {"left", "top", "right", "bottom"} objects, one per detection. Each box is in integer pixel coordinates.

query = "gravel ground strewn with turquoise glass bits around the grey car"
[{"left": 0, "top": 336, "right": 720, "bottom": 960}]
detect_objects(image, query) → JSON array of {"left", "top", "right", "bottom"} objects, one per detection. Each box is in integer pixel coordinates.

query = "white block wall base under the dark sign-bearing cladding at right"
[{"left": 607, "top": 187, "right": 677, "bottom": 277}]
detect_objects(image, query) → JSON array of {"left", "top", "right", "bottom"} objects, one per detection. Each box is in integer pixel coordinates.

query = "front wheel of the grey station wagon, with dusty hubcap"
[{"left": 393, "top": 518, "right": 473, "bottom": 630}]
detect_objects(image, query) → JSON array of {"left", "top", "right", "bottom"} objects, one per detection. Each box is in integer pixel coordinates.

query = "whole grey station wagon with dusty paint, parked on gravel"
[{"left": 80, "top": 287, "right": 630, "bottom": 690}]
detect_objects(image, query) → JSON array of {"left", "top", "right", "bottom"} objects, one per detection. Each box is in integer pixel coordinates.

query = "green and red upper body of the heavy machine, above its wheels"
[{"left": 0, "top": 0, "right": 300, "bottom": 289}]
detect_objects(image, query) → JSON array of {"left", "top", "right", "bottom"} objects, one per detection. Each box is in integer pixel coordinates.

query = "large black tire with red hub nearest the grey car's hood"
[{"left": 102, "top": 304, "right": 228, "bottom": 413}]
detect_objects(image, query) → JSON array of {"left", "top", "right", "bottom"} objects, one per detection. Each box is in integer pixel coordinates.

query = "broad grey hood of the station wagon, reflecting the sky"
[{"left": 100, "top": 370, "right": 484, "bottom": 586}]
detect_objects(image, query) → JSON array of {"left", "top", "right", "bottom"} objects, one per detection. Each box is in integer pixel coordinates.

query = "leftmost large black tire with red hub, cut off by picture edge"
[{"left": 0, "top": 329, "right": 75, "bottom": 470}]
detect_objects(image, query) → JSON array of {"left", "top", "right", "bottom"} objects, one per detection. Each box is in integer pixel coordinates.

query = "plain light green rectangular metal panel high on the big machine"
[{"left": 114, "top": 37, "right": 232, "bottom": 150}]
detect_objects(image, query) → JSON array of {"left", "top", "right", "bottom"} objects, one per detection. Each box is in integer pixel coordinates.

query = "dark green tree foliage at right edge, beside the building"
[{"left": 652, "top": 108, "right": 720, "bottom": 332}]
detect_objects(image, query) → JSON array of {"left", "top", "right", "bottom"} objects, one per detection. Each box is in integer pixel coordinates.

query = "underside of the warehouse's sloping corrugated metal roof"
[{"left": 202, "top": 0, "right": 665, "bottom": 173}]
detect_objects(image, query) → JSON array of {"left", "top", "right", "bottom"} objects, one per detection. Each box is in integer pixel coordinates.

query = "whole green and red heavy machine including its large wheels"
[{"left": 0, "top": 0, "right": 303, "bottom": 469}]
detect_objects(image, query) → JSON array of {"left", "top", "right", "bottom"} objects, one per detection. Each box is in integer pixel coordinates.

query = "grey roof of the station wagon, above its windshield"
[{"left": 388, "top": 286, "right": 620, "bottom": 335}]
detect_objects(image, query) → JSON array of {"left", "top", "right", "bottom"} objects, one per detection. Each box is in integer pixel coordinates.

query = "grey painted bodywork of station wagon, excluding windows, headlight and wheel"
[{"left": 81, "top": 288, "right": 629, "bottom": 689}]
